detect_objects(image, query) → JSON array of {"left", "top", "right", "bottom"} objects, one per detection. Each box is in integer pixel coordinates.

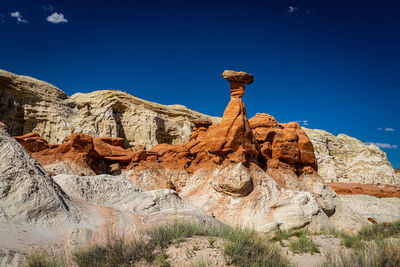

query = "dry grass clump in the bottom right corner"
[{"left": 322, "top": 240, "right": 400, "bottom": 267}]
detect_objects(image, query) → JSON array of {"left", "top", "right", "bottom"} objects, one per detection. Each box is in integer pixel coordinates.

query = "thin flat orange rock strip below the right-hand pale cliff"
[{"left": 328, "top": 182, "right": 400, "bottom": 198}]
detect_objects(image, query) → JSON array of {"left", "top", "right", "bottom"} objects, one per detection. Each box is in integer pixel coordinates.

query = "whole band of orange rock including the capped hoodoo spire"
[{"left": 16, "top": 71, "right": 317, "bottom": 184}]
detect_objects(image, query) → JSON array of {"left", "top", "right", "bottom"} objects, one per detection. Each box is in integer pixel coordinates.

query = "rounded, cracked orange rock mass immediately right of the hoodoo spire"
[{"left": 250, "top": 113, "right": 317, "bottom": 173}]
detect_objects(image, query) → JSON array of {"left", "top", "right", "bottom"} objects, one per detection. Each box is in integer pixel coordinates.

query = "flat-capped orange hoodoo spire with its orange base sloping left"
[{"left": 128, "top": 71, "right": 260, "bottom": 174}]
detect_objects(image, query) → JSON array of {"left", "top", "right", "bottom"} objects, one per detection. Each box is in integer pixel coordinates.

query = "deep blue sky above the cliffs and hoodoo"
[{"left": 0, "top": 0, "right": 400, "bottom": 168}]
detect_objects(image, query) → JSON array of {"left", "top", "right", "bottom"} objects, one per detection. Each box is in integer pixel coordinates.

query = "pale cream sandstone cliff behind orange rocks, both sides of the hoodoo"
[{"left": 0, "top": 70, "right": 400, "bottom": 187}]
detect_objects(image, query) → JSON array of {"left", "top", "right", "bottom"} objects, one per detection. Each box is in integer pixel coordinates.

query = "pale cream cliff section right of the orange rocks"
[{"left": 303, "top": 128, "right": 400, "bottom": 185}]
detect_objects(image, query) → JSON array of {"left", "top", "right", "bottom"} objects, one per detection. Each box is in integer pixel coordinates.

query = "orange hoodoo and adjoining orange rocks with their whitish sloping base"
[{"left": 127, "top": 71, "right": 366, "bottom": 231}]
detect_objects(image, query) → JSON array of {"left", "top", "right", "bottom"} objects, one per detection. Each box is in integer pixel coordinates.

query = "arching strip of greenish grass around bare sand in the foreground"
[{"left": 74, "top": 221, "right": 291, "bottom": 267}]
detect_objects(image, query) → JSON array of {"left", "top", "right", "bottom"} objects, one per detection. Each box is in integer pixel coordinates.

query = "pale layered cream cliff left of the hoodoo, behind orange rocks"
[{"left": 0, "top": 70, "right": 219, "bottom": 148}]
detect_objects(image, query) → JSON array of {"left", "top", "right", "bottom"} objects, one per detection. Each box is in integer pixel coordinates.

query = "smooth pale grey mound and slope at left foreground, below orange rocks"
[{"left": 0, "top": 123, "right": 218, "bottom": 265}]
